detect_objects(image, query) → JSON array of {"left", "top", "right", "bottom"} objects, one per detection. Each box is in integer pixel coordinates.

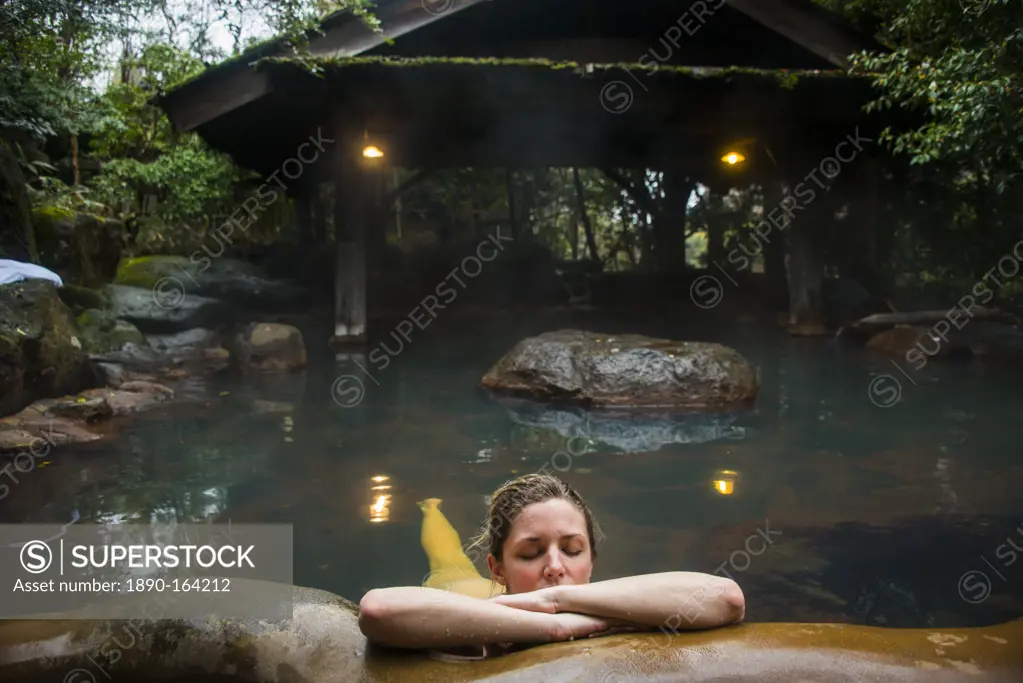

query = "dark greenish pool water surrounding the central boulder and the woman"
[{"left": 0, "top": 312, "right": 1023, "bottom": 627}]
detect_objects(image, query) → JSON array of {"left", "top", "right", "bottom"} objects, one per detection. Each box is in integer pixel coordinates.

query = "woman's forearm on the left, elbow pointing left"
[{"left": 359, "top": 587, "right": 568, "bottom": 648}]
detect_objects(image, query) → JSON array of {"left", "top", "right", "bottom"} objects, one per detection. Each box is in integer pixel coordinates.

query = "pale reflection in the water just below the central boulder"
[{"left": 500, "top": 399, "right": 746, "bottom": 453}]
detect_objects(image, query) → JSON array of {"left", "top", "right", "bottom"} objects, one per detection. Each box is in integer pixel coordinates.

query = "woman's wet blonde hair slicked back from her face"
[{"left": 468, "top": 473, "right": 604, "bottom": 561}]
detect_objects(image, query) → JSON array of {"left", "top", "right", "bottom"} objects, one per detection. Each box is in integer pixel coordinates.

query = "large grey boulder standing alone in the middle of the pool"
[{"left": 481, "top": 329, "right": 758, "bottom": 410}]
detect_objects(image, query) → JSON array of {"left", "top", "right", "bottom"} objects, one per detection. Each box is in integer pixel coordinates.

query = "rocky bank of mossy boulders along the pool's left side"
[{"left": 0, "top": 257, "right": 307, "bottom": 458}]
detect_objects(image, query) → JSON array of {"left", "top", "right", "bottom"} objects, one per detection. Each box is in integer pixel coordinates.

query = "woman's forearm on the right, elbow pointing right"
[{"left": 546, "top": 572, "right": 746, "bottom": 630}]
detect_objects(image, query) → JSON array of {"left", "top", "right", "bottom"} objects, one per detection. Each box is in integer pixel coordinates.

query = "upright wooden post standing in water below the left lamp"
[{"left": 330, "top": 155, "right": 369, "bottom": 347}]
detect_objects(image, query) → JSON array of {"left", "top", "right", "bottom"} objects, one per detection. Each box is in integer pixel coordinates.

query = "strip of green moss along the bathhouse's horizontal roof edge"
[{"left": 257, "top": 55, "right": 872, "bottom": 87}]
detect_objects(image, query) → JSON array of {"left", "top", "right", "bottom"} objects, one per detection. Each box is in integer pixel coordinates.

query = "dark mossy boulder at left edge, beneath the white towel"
[{"left": 0, "top": 279, "right": 98, "bottom": 415}]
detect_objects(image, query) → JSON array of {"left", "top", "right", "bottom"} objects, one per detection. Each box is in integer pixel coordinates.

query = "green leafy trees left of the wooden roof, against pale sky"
[{"left": 0, "top": 0, "right": 374, "bottom": 249}]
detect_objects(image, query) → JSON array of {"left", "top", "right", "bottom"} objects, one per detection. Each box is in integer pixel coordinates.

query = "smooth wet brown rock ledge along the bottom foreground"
[{"left": 0, "top": 579, "right": 1023, "bottom": 683}]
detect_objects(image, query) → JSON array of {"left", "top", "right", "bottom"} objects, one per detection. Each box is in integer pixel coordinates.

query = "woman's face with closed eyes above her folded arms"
[{"left": 487, "top": 498, "right": 593, "bottom": 593}]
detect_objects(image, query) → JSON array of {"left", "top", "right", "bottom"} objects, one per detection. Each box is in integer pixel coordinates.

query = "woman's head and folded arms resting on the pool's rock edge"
[{"left": 359, "top": 474, "right": 746, "bottom": 651}]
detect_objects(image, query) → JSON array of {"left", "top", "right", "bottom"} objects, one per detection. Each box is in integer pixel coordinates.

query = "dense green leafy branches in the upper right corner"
[{"left": 819, "top": 0, "right": 1023, "bottom": 187}]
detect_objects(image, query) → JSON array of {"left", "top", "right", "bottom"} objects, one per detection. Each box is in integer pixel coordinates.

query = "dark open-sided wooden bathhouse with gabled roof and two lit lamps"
[{"left": 159, "top": 0, "right": 900, "bottom": 345}]
